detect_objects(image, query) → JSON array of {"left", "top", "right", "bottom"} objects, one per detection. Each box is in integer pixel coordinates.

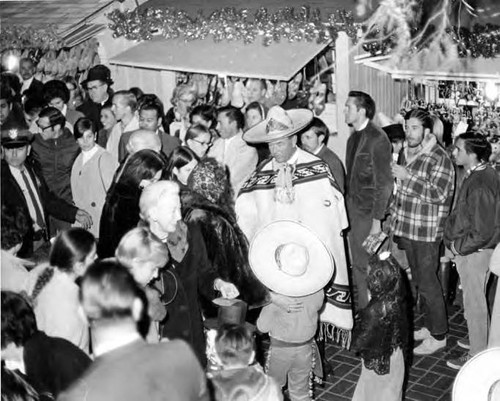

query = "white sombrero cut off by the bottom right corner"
[{"left": 452, "top": 347, "right": 500, "bottom": 401}]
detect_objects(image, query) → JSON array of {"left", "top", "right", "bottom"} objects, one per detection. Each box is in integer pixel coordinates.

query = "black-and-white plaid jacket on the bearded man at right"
[{"left": 391, "top": 144, "right": 455, "bottom": 242}]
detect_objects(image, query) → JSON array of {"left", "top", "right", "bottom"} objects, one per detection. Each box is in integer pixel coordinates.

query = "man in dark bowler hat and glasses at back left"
[{"left": 77, "top": 64, "right": 113, "bottom": 131}]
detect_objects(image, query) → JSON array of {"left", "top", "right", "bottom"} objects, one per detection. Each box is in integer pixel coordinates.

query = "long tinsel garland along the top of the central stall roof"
[{"left": 107, "top": 6, "right": 357, "bottom": 46}]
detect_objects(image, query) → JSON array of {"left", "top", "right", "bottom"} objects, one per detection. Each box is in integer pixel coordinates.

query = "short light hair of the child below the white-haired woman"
[{"left": 115, "top": 227, "right": 168, "bottom": 269}]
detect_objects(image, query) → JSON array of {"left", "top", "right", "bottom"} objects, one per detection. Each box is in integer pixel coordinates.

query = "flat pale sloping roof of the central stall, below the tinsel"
[{"left": 110, "top": 37, "right": 327, "bottom": 81}]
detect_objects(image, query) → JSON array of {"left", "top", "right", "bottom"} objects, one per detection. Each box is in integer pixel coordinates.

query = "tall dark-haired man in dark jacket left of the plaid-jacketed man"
[{"left": 344, "top": 91, "right": 393, "bottom": 308}]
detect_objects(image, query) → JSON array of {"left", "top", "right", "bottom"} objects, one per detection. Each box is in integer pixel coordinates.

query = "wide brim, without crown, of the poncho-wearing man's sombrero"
[{"left": 243, "top": 109, "right": 313, "bottom": 143}]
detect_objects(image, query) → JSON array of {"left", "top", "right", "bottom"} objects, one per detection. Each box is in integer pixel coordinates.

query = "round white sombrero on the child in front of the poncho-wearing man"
[{"left": 249, "top": 220, "right": 335, "bottom": 297}]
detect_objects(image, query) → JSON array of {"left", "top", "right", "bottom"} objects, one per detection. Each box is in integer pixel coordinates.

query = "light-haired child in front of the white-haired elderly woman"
[{"left": 115, "top": 227, "right": 168, "bottom": 343}]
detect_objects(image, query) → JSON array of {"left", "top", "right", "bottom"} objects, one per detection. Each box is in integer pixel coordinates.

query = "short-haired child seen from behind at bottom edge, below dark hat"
[{"left": 211, "top": 324, "right": 283, "bottom": 401}]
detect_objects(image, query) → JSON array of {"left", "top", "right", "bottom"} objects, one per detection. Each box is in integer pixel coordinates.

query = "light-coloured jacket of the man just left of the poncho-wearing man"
[{"left": 208, "top": 131, "right": 259, "bottom": 197}]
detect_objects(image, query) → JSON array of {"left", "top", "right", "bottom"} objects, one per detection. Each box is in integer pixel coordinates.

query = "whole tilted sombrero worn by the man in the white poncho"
[{"left": 243, "top": 106, "right": 313, "bottom": 143}]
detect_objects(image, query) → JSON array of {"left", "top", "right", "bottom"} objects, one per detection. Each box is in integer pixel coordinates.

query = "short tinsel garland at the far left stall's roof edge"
[{"left": 0, "top": 25, "right": 63, "bottom": 51}]
